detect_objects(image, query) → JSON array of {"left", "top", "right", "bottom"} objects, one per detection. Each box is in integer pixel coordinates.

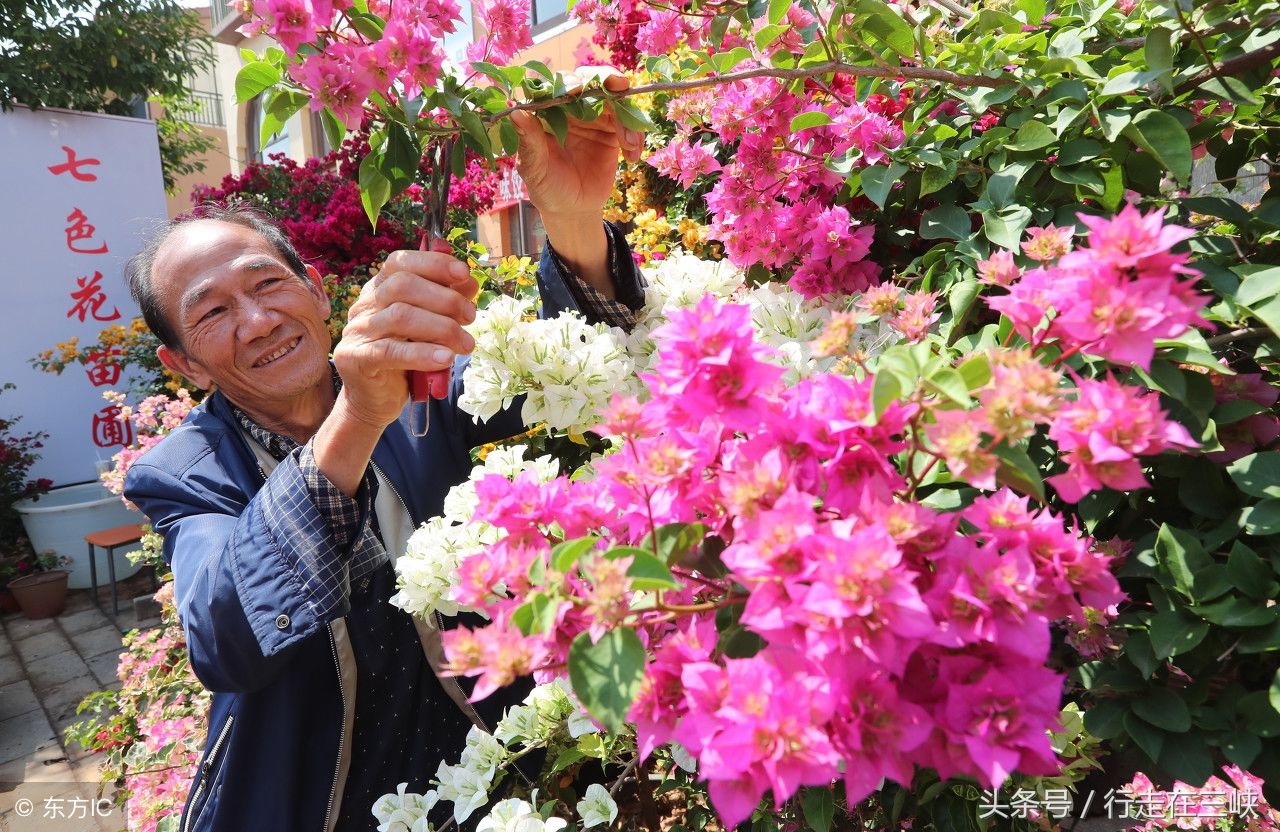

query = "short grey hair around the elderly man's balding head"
[{"left": 124, "top": 205, "right": 307, "bottom": 349}]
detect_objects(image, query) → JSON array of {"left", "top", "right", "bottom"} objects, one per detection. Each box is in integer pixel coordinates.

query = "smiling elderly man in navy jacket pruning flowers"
[{"left": 125, "top": 92, "right": 641, "bottom": 832}]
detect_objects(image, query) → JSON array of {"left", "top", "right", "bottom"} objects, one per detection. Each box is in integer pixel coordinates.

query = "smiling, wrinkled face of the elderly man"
[{"left": 151, "top": 220, "right": 330, "bottom": 416}]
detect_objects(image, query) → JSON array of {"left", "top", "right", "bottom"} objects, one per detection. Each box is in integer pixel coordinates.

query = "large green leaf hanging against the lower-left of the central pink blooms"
[{"left": 568, "top": 627, "right": 645, "bottom": 733}]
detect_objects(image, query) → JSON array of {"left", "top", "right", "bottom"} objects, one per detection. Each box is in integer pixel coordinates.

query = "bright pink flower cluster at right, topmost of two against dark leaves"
[{"left": 979, "top": 205, "right": 1208, "bottom": 370}]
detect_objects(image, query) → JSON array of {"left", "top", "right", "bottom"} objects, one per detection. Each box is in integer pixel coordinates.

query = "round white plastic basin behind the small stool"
[{"left": 14, "top": 483, "right": 142, "bottom": 589}]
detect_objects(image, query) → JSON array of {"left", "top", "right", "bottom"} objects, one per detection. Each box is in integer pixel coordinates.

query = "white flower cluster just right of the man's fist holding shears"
[{"left": 458, "top": 297, "right": 634, "bottom": 434}]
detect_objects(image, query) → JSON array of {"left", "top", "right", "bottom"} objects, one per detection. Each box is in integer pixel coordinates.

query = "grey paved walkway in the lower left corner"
[{"left": 0, "top": 584, "right": 159, "bottom": 832}]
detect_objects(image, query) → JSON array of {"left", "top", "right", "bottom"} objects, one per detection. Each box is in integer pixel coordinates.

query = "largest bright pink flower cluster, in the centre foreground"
[{"left": 445, "top": 291, "right": 1121, "bottom": 826}]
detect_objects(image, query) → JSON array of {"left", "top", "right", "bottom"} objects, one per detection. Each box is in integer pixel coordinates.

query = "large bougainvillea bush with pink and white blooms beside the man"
[{"left": 225, "top": 0, "right": 1280, "bottom": 829}]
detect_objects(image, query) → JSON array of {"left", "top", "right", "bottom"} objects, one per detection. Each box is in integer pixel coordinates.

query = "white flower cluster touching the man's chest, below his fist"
[{"left": 392, "top": 445, "right": 559, "bottom": 621}]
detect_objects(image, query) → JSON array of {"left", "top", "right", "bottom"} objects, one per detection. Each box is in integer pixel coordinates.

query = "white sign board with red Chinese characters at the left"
[{"left": 0, "top": 108, "right": 166, "bottom": 485}]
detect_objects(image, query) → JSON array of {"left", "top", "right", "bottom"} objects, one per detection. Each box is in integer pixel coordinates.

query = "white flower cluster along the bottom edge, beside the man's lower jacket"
[{"left": 374, "top": 680, "right": 618, "bottom": 832}]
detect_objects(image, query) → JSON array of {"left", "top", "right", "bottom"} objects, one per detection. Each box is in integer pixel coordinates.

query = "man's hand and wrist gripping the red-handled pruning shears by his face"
[{"left": 315, "top": 245, "right": 479, "bottom": 494}]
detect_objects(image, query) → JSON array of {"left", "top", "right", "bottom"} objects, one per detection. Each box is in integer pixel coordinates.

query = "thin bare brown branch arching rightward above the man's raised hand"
[{"left": 484, "top": 61, "right": 1008, "bottom": 122}]
